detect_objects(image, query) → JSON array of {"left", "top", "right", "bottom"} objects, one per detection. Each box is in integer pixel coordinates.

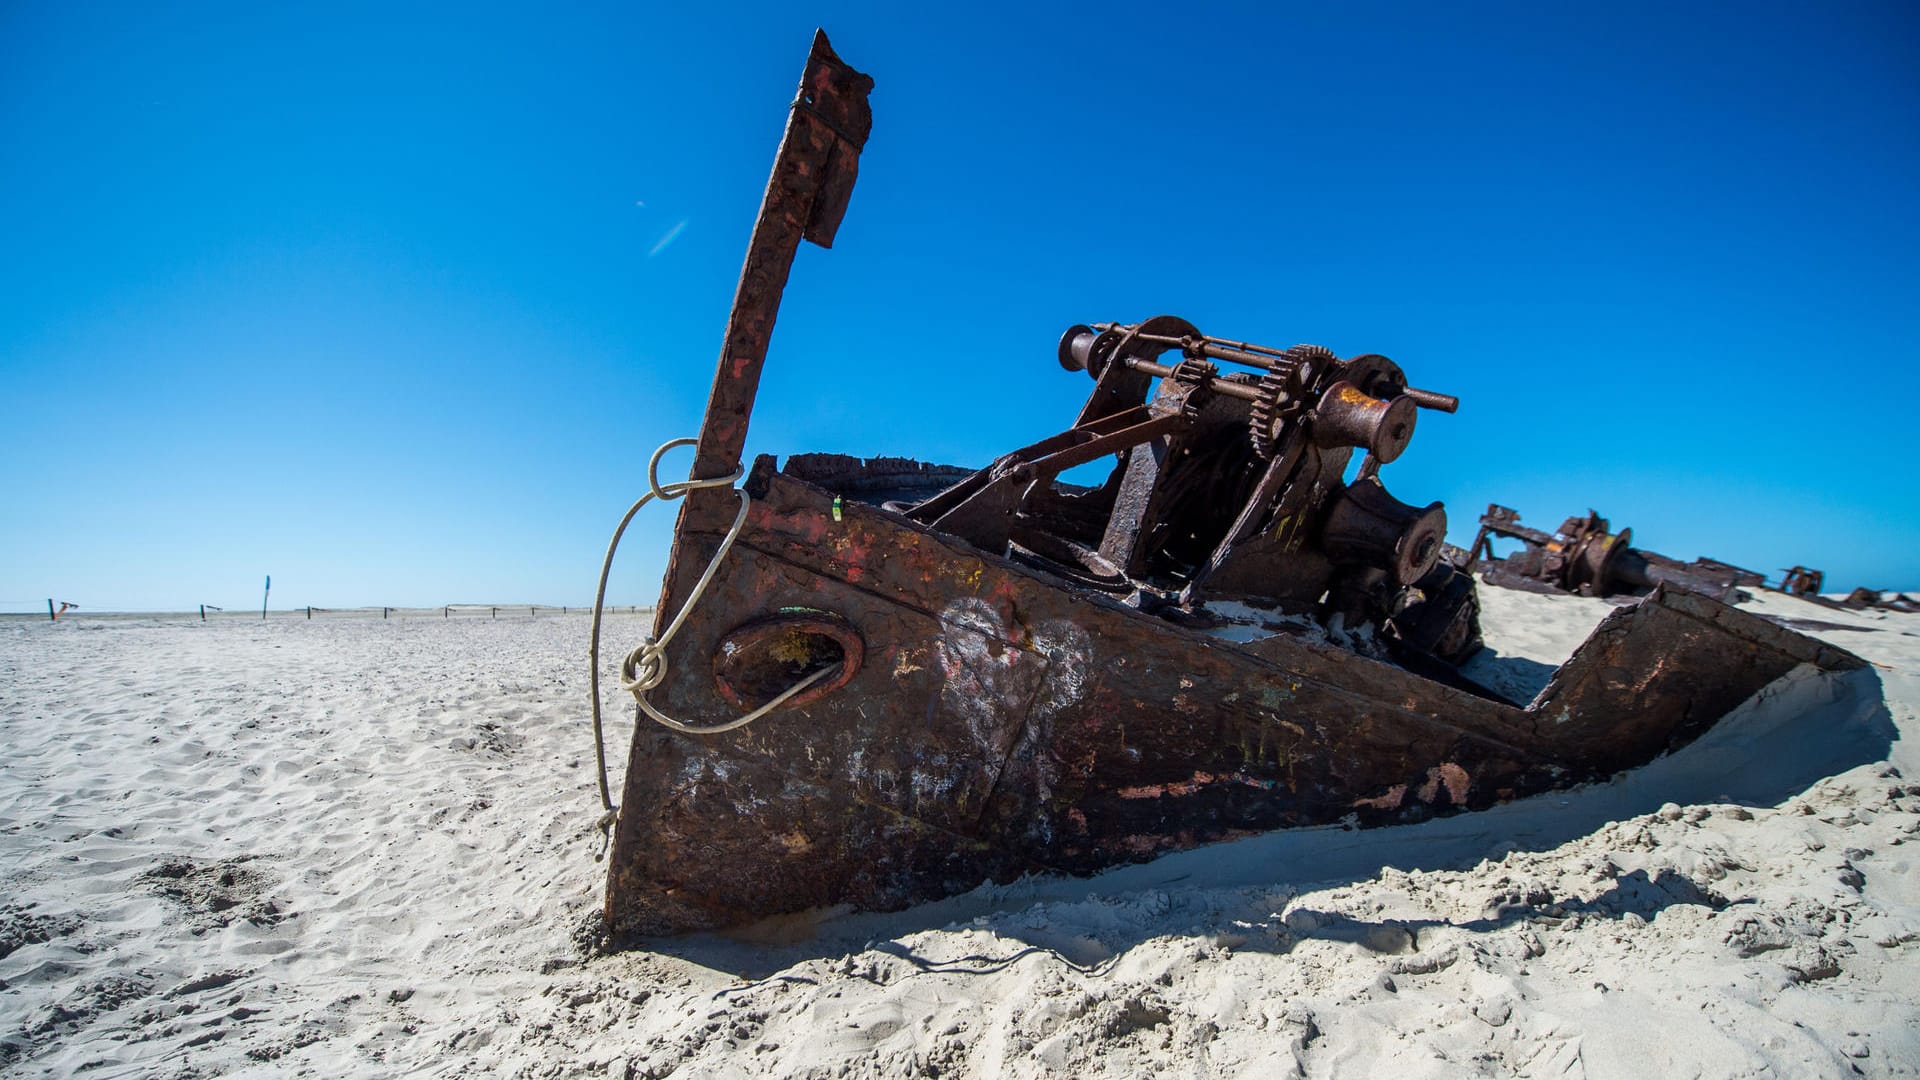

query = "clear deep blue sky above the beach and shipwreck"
[{"left": 0, "top": 2, "right": 1920, "bottom": 611}]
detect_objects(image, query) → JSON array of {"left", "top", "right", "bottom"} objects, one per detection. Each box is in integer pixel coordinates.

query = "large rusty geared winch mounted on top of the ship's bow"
[{"left": 893, "top": 315, "right": 1478, "bottom": 661}]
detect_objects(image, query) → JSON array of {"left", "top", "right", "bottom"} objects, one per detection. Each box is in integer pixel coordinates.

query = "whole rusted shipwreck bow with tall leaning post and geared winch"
[{"left": 595, "top": 35, "right": 1860, "bottom": 936}]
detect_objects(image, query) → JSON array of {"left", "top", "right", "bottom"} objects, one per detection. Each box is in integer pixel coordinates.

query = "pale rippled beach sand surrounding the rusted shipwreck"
[{"left": 0, "top": 588, "right": 1920, "bottom": 1080}]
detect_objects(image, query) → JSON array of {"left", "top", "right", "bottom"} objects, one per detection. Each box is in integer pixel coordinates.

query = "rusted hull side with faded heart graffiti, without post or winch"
[{"left": 607, "top": 457, "right": 1860, "bottom": 934}]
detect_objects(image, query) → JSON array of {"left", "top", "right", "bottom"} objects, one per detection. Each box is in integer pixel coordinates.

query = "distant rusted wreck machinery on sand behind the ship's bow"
[{"left": 1463, "top": 503, "right": 1766, "bottom": 603}]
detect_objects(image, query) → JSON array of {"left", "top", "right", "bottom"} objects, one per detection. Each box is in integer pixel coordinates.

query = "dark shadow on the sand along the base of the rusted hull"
[{"left": 628, "top": 669, "right": 1899, "bottom": 978}]
